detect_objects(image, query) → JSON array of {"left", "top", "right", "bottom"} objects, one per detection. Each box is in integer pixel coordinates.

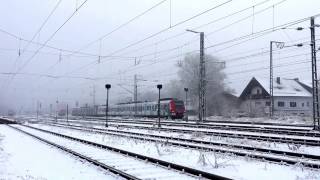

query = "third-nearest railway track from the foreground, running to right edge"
[{"left": 47, "top": 120, "right": 320, "bottom": 146}]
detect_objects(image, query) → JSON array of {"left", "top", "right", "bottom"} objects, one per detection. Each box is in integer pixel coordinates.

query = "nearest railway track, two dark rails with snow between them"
[{"left": 10, "top": 125, "right": 228, "bottom": 180}]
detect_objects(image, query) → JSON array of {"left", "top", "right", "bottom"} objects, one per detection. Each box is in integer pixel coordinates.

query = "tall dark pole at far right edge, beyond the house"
[{"left": 310, "top": 17, "right": 320, "bottom": 129}]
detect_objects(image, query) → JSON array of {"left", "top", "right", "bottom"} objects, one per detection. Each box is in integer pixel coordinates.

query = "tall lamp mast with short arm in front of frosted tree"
[{"left": 186, "top": 29, "right": 206, "bottom": 123}]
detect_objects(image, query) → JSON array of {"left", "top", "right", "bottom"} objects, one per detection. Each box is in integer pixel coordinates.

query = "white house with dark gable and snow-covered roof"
[{"left": 239, "top": 77, "right": 312, "bottom": 115}]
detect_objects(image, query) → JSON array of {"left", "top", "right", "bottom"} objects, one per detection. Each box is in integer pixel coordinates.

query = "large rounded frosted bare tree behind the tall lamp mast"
[{"left": 172, "top": 54, "right": 229, "bottom": 115}]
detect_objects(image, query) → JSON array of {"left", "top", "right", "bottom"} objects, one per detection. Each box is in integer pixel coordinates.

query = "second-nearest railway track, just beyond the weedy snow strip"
[{"left": 36, "top": 124, "right": 320, "bottom": 168}]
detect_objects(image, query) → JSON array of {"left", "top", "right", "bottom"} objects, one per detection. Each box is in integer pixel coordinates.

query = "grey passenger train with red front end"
[{"left": 71, "top": 98, "right": 185, "bottom": 119}]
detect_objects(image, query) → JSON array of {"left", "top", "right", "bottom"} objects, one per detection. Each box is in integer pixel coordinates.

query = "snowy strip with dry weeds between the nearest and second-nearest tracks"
[{"left": 26, "top": 125, "right": 320, "bottom": 179}]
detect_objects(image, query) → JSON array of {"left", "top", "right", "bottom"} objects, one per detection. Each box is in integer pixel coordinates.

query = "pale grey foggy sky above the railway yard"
[{"left": 0, "top": 0, "right": 320, "bottom": 112}]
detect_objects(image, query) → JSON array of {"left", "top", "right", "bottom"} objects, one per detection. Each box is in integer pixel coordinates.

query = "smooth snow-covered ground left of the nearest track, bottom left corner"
[{"left": 0, "top": 125, "right": 119, "bottom": 180}]
